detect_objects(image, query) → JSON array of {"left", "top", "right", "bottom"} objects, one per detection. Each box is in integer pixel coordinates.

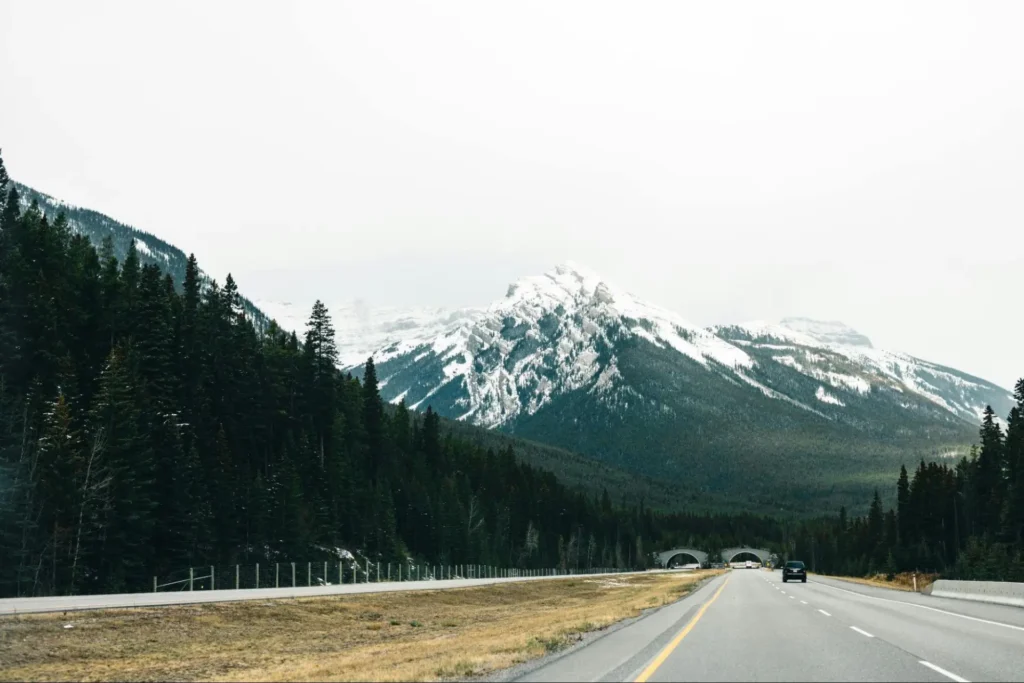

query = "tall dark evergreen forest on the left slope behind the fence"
[{"left": 0, "top": 150, "right": 776, "bottom": 596}]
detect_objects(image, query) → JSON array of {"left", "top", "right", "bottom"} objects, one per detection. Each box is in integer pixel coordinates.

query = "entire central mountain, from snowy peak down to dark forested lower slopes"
[{"left": 327, "top": 262, "right": 1012, "bottom": 496}]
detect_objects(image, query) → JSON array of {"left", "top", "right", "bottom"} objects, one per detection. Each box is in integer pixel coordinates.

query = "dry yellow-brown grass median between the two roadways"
[{"left": 0, "top": 571, "right": 717, "bottom": 681}]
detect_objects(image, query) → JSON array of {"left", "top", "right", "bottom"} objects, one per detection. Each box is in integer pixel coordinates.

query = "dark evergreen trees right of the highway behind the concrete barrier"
[{"left": 783, "top": 395, "right": 1024, "bottom": 582}]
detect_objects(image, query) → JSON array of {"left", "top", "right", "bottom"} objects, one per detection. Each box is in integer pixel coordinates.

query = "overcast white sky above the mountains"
[{"left": 0, "top": 0, "right": 1024, "bottom": 387}]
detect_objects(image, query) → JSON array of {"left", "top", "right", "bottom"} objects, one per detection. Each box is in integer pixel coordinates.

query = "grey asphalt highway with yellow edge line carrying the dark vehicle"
[{"left": 516, "top": 569, "right": 1024, "bottom": 682}]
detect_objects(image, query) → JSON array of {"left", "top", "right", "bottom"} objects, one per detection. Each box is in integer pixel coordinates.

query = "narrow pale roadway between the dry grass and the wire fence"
[{"left": 0, "top": 569, "right": 665, "bottom": 615}]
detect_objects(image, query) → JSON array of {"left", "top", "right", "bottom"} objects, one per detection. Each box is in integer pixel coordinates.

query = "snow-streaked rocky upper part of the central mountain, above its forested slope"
[{"left": 342, "top": 262, "right": 1011, "bottom": 427}]
